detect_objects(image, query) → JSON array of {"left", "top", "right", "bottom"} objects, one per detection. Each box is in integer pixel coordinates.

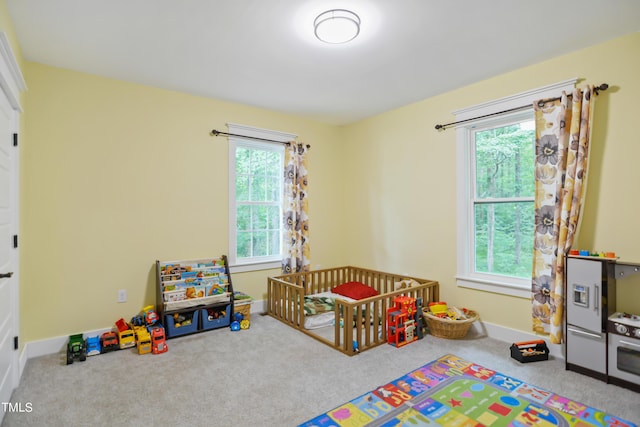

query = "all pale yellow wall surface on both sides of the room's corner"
[{"left": 5, "top": 0, "right": 640, "bottom": 342}]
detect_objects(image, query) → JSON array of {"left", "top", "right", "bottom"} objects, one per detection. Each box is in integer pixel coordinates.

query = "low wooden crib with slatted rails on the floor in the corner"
[{"left": 267, "top": 266, "right": 440, "bottom": 356}]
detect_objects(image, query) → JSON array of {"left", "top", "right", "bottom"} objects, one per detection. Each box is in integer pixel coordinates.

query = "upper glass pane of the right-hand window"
[{"left": 475, "top": 121, "right": 535, "bottom": 199}]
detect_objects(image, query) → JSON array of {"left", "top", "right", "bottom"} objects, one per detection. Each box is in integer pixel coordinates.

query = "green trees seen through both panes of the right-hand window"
[{"left": 472, "top": 119, "right": 535, "bottom": 278}]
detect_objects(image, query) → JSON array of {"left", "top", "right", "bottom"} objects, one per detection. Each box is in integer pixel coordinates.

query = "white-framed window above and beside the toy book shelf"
[{"left": 228, "top": 124, "right": 295, "bottom": 272}]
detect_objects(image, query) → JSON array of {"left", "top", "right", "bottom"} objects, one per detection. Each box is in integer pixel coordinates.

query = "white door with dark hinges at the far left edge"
[{"left": 0, "top": 69, "right": 20, "bottom": 423}]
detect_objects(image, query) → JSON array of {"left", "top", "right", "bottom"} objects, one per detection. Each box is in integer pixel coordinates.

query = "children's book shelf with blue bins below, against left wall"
[{"left": 156, "top": 255, "right": 233, "bottom": 338}]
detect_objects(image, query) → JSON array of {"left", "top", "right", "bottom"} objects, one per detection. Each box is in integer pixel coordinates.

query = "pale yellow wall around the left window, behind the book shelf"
[{"left": 20, "top": 62, "right": 343, "bottom": 341}]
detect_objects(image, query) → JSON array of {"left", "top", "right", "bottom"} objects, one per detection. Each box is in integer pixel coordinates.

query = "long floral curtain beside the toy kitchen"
[{"left": 532, "top": 87, "right": 595, "bottom": 344}]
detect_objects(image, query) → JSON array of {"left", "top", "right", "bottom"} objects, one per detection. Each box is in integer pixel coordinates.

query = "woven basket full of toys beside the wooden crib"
[{"left": 422, "top": 301, "right": 478, "bottom": 339}]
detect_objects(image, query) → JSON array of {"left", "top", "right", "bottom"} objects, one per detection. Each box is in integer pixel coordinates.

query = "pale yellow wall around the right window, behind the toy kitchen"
[{"left": 344, "top": 33, "right": 640, "bottom": 331}]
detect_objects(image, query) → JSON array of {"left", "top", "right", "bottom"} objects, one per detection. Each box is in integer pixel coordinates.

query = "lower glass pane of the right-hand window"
[{"left": 474, "top": 202, "right": 534, "bottom": 278}]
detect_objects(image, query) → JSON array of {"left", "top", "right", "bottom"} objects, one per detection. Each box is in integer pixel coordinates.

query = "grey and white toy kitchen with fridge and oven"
[{"left": 565, "top": 255, "right": 640, "bottom": 391}]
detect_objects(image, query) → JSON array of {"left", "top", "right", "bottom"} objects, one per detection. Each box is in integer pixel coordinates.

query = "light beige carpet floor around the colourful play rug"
[{"left": 2, "top": 314, "right": 640, "bottom": 427}]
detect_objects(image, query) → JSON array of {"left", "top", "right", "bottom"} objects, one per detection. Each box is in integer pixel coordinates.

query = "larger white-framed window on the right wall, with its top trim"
[{"left": 456, "top": 80, "right": 575, "bottom": 298}]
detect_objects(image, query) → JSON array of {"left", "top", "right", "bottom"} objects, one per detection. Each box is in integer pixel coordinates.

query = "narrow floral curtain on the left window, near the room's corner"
[{"left": 282, "top": 142, "right": 311, "bottom": 274}]
